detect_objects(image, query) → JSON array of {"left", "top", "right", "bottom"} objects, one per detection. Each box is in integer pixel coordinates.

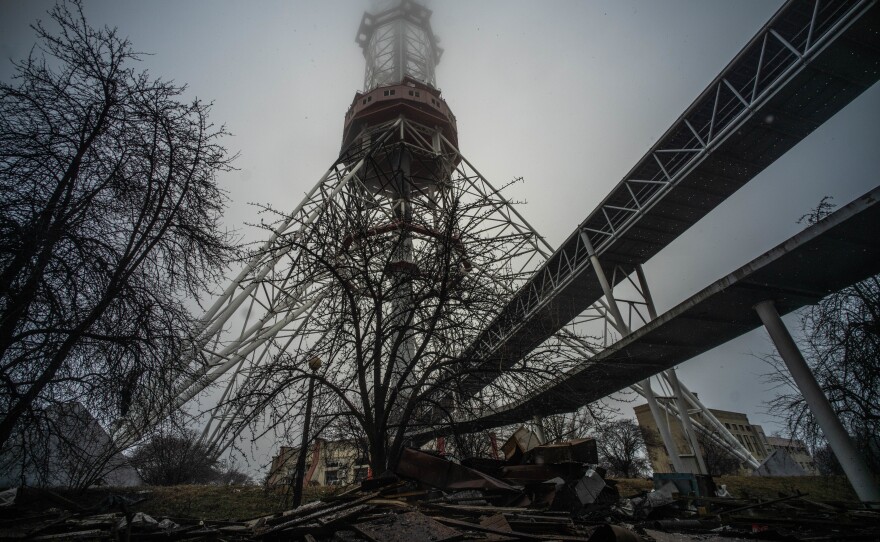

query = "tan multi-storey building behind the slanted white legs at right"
[{"left": 633, "top": 397, "right": 772, "bottom": 472}]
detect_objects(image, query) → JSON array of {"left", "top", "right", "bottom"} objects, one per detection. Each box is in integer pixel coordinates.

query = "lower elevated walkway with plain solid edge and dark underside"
[{"left": 412, "top": 188, "right": 880, "bottom": 440}]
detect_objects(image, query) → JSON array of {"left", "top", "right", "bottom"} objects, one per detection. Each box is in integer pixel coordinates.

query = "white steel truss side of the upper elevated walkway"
[{"left": 458, "top": 0, "right": 876, "bottom": 386}]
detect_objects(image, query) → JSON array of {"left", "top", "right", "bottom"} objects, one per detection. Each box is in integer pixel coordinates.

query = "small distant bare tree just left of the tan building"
[{"left": 595, "top": 419, "right": 648, "bottom": 478}]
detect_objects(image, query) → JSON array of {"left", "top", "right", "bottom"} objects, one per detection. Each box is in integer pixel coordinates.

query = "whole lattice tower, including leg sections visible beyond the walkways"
[{"left": 115, "top": 0, "right": 768, "bottom": 480}]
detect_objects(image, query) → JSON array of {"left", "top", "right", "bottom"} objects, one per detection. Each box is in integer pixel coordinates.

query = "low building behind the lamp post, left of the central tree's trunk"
[{"left": 266, "top": 438, "right": 369, "bottom": 488}]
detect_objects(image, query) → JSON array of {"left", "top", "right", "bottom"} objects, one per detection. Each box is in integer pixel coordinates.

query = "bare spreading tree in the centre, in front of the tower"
[{"left": 217, "top": 136, "right": 592, "bottom": 474}]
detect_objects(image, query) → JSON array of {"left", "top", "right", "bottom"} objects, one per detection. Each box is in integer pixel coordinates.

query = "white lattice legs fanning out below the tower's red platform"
[{"left": 118, "top": 117, "right": 588, "bottom": 455}]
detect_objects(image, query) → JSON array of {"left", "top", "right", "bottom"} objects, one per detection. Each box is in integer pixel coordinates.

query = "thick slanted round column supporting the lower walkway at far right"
[{"left": 755, "top": 300, "right": 880, "bottom": 502}]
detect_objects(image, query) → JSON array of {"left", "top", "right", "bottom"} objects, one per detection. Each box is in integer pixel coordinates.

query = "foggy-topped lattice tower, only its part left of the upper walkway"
[{"left": 117, "top": 0, "right": 564, "bottom": 455}]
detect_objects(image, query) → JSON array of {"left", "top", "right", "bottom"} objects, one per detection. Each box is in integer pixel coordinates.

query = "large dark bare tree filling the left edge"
[{"left": 0, "top": 1, "right": 232, "bottom": 468}]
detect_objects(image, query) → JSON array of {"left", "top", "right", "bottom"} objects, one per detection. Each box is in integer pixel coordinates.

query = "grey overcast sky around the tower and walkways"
[{"left": 0, "top": 0, "right": 880, "bottom": 468}]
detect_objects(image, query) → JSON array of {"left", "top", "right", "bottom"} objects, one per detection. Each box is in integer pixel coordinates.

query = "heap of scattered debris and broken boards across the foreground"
[{"left": 0, "top": 433, "right": 880, "bottom": 542}]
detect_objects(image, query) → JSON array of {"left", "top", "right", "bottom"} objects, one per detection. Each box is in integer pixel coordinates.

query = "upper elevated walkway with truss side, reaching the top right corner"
[{"left": 463, "top": 2, "right": 880, "bottom": 396}]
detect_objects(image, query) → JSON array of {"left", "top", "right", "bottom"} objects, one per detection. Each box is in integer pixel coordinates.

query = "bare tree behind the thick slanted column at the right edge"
[{"left": 763, "top": 197, "right": 880, "bottom": 473}]
